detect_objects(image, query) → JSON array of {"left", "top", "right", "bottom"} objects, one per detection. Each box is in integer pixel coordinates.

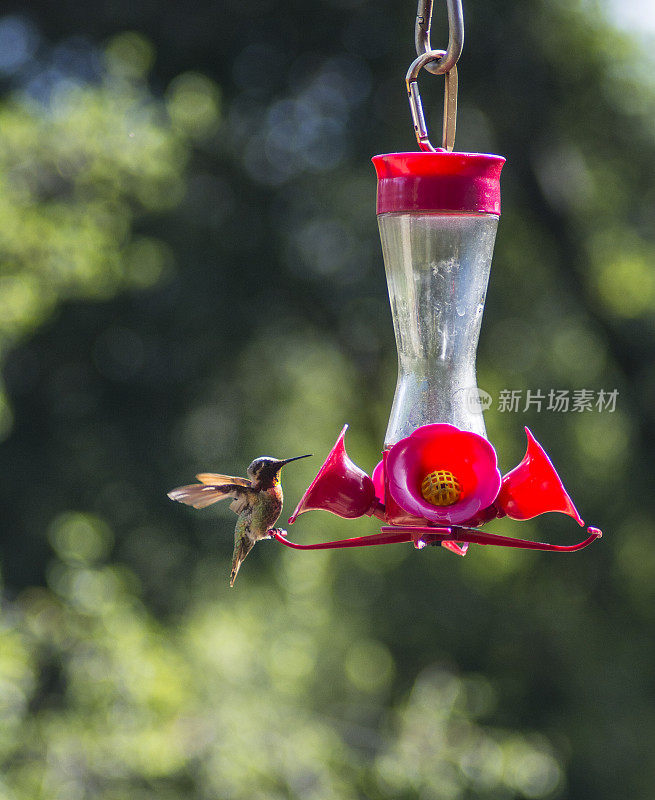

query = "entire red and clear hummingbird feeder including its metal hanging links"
[{"left": 273, "top": 0, "right": 602, "bottom": 555}]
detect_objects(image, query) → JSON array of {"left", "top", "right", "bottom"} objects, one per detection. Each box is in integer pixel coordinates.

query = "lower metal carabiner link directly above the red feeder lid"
[{"left": 405, "top": 50, "right": 457, "bottom": 153}]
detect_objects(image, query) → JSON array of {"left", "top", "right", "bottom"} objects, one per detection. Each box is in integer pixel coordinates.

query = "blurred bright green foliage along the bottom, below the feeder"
[{"left": 0, "top": 514, "right": 562, "bottom": 800}]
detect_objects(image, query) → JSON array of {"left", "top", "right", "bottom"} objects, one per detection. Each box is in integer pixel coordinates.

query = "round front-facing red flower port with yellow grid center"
[{"left": 386, "top": 423, "right": 501, "bottom": 525}]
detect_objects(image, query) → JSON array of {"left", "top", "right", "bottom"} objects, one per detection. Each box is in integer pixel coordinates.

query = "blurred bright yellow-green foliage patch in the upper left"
[{"left": 0, "top": 34, "right": 217, "bottom": 434}]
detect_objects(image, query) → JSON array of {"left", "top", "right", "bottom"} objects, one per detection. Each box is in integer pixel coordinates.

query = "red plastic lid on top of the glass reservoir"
[{"left": 372, "top": 150, "right": 505, "bottom": 214}]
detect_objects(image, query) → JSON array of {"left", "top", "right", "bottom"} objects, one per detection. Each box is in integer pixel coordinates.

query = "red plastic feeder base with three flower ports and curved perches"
[{"left": 274, "top": 423, "right": 602, "bottom": 555}]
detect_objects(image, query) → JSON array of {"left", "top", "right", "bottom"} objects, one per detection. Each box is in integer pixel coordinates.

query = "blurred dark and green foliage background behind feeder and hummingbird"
[{"left": 0, "top": 0, "right": 655, "bottom": 800}]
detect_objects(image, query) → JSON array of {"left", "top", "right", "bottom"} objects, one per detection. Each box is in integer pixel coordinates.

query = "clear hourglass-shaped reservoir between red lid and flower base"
[{"left": 378, "top": 211, "right": 498, "bottom": 449}]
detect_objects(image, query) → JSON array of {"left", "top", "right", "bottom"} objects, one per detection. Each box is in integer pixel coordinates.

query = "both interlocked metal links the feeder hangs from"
[{"left": 405, "top": 0, "right": 464, "bottom": 152}]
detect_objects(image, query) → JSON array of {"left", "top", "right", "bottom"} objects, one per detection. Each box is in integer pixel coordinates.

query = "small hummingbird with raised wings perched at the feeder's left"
[{"left": 168, "top": 453, "right": 312, "bottom": 586}]
